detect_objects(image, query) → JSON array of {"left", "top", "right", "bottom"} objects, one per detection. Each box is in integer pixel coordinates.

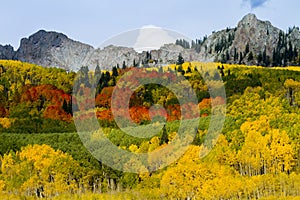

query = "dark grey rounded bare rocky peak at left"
[{"left": 14, "top": 30, "right": 94, "bottom": 69}]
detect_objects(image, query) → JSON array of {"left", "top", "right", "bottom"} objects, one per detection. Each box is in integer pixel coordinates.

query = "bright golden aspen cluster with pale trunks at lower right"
[{"left": 238, "top": 116, "right": 295, "bottom": 176}]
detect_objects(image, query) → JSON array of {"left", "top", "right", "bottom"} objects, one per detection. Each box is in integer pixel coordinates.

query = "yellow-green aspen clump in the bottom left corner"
[{"left": 1, "top": 145, "right": 79, "bottom": 197}]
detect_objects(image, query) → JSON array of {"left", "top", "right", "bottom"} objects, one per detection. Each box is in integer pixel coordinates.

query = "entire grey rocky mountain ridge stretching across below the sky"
[{"left": 0, "top": 14, "right": 300, "bottom": 71}]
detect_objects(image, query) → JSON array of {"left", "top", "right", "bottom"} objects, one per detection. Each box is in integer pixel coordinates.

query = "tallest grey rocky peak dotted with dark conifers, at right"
[{"left": 200, "top": 14, "right": 300, "bottom": 66}]
